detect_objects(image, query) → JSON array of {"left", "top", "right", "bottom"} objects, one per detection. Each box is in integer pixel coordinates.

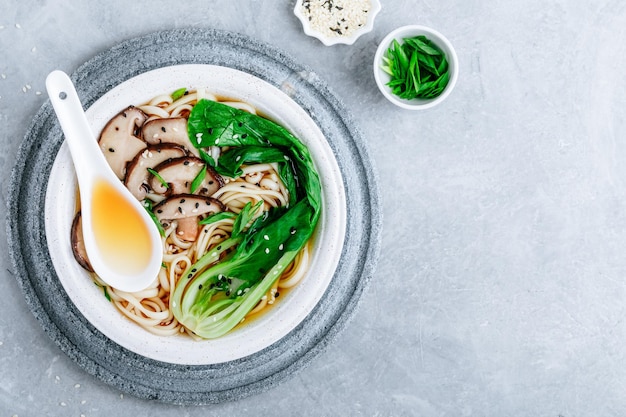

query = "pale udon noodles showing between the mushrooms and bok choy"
[{"left": 86, "top": 89, "right": 310, "bottom": 338}]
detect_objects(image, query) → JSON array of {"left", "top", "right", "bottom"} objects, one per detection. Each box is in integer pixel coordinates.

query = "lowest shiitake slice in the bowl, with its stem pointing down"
[{"left": 153, "top": 194, "right": 225, "bottom": 242}]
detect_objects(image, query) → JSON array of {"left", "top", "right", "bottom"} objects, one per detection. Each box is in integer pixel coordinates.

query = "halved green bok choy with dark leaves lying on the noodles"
[{"left": 171, "top": 100, "right": 321, "bottom": 338}]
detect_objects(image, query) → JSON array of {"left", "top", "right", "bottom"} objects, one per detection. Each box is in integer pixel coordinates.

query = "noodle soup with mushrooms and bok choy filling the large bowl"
[{"left": 72, "top": 89, "right": 321, "bottom": 339}]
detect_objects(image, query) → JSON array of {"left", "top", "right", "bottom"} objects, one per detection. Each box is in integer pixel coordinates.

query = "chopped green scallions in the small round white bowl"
[{"left": 381, "top": 35, "right": 450, "bottom": 100}]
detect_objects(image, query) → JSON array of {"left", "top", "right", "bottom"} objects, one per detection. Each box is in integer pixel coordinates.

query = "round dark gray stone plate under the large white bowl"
[{"left": 7, "top": 30, "right": 381, "bottom": 404}]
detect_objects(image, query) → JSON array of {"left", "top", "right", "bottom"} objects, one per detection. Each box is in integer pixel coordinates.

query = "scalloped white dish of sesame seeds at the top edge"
[{"left": 293, "top": 0, "right": 381, "bottom": 46}]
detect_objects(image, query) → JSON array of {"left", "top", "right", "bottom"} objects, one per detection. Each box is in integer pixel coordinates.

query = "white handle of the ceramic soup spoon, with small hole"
[{"left": 46, "top": 70, "right": 109, "bottom": 186}]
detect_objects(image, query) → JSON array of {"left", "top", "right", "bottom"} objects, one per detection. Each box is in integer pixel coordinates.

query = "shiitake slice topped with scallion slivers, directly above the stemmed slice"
[{"left": 150, "top": 156, "right": 224, "bottom": 195}]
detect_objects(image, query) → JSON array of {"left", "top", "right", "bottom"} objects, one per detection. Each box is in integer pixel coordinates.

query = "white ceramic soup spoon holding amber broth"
[{"left": 46, "top": 71, "right": 163, "bottom": 292}]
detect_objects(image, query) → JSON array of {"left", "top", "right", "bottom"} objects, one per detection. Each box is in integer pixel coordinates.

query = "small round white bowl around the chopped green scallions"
[{"left": 374, "top": 25, "right": 459, "bottom": 110}]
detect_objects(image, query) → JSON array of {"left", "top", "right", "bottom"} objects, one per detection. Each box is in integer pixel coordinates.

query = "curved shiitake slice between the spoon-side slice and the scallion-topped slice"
[{"left": 124, "top": 143, "right": 187, "bottom": 201}]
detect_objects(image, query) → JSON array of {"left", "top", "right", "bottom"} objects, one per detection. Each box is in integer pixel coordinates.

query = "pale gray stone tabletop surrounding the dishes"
[{"left": 0, "top": 0, "right": 626, "bottom": 417}]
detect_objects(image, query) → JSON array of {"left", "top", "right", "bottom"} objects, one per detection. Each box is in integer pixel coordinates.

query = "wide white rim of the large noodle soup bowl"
[{"left": 45, "top": 64, "right": 346, "bottom": 365}]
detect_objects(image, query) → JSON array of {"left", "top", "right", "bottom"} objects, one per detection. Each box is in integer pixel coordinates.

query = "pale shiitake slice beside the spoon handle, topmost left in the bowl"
[{"left": 98, "top": 106, "right": 148, "bottom": 180}]
